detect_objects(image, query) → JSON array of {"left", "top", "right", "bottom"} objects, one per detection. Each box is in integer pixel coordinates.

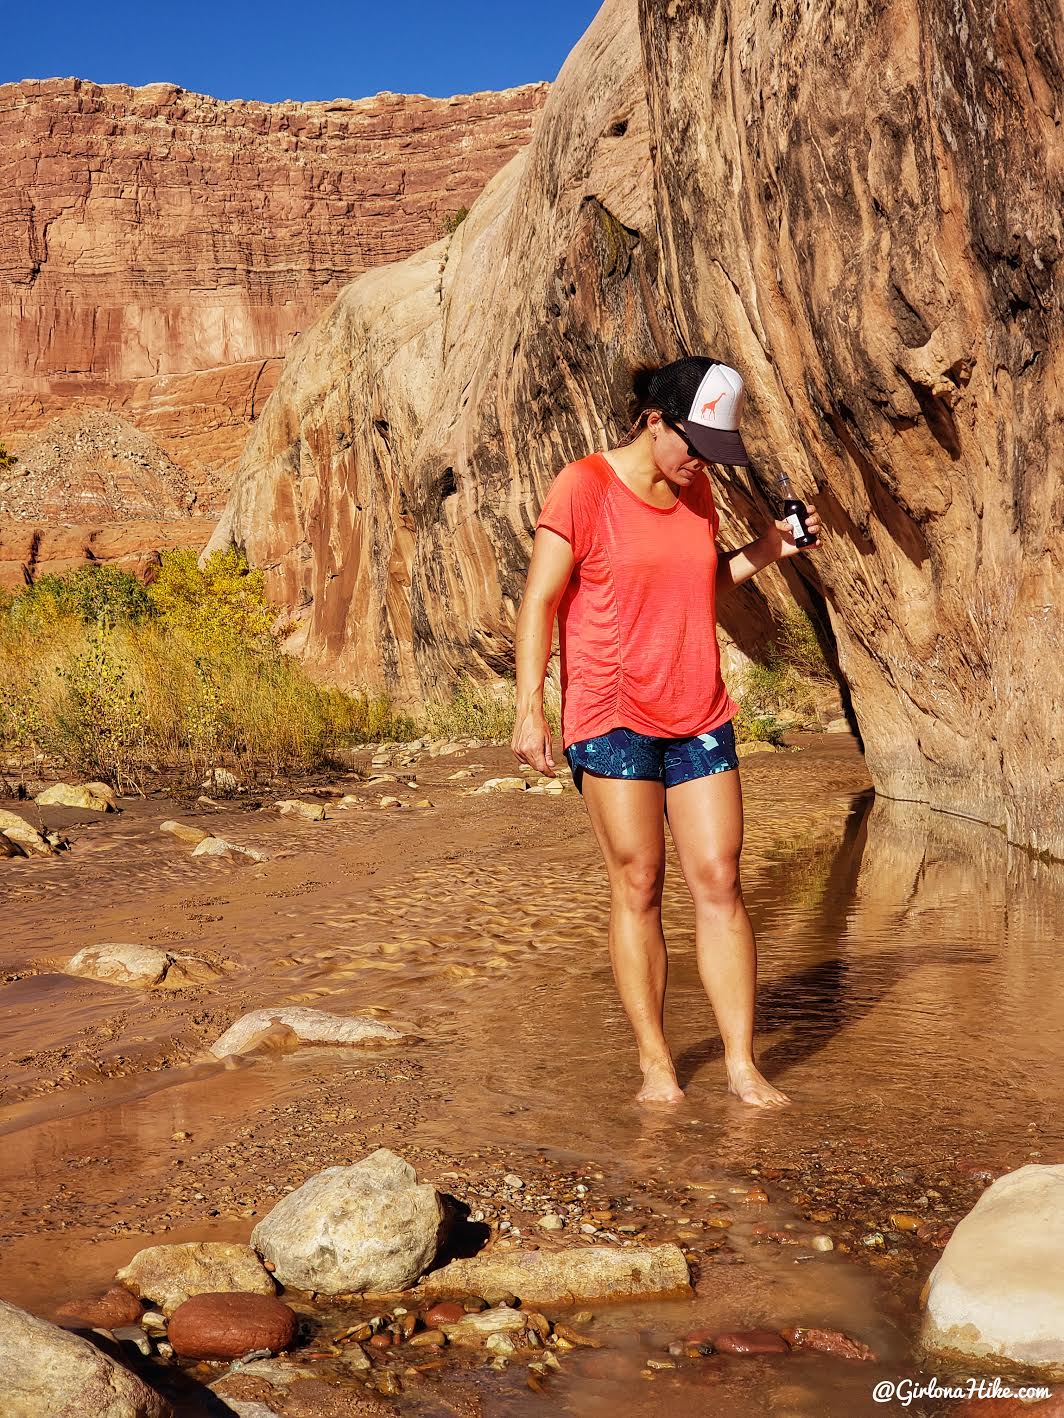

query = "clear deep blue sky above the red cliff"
[{"left": 0, "top": 0, "right": 600, "bottom": 102}]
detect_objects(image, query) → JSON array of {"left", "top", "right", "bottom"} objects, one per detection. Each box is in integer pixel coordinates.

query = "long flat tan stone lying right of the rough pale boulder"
[{"left": 421, "top": 1245, "right": 689, "bottom": 1305}]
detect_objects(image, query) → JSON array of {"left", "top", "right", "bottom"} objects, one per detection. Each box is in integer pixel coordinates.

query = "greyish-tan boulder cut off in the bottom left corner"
[{"left": 0, "top": 1300, "right": 173, "bottom": 1418}]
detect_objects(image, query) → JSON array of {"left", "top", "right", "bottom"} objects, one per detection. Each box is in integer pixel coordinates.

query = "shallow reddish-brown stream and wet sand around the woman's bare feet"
[{"left": 0, "top": 736, "right": 1064, "bottom": 1418}]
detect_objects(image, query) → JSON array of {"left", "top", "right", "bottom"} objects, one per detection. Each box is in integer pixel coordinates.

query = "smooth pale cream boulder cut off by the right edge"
[{"left": 921, "top": 1163, "right": 1064, "bottom": 1377}]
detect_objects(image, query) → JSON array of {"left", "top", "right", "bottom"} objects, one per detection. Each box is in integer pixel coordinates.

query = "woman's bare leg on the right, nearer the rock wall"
[{"left": 665, "top": 769, "right": 790, "bottom": 1107}]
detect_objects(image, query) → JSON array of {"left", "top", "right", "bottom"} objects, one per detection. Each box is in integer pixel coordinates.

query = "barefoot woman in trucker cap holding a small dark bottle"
[{"left": 511, "top": 356, "right": 820, "bottom": 1107}]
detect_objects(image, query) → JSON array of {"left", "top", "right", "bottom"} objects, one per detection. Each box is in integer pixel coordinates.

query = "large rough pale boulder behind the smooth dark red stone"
[{"left": 251, "top": 1147, "right": 447, "bottom": 1295}]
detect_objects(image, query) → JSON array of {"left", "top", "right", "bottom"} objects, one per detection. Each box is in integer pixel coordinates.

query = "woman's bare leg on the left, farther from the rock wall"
[{"left": 582, "top": 771, "right": 684, "bottom": 1103}]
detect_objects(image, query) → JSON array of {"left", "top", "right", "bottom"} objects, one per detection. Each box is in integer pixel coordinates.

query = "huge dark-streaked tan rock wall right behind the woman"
[{"left": 213, "top": 0, "right": 1064, "bottom": 855}]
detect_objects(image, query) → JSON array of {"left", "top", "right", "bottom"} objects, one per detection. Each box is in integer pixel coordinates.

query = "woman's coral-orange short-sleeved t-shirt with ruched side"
[{"left": 536, "top": 452, "right": 738, "bottom": 749}]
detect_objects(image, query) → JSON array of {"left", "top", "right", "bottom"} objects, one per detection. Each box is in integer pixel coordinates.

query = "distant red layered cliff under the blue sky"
[{"left": 0, "top": 79, "right": 546, "bottom": 499}]
